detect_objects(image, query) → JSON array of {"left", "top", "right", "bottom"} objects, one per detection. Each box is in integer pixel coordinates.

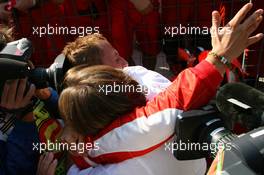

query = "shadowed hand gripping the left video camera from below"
[{"left": 0, "top": 79, "right": 36, "bottom": 110}]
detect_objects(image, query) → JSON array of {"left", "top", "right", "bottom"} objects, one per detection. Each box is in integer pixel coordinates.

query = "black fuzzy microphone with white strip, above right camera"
[{"left": 216, "top": 83, "right": 264, "bottom": 130}]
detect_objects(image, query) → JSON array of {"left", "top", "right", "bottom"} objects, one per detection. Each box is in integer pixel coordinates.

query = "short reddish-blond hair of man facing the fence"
[{"left": 62, "top": 33, "right": 107, "bottom": 66}]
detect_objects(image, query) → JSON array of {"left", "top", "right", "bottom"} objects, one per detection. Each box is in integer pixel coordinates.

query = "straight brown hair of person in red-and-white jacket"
[{"left": 59, "top": 65, "right": 146, "bottom": 135}]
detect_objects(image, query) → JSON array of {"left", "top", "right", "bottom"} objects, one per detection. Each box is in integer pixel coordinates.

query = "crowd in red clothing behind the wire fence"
[{"left": 0, "top": 0, "right": 263, "bottom": 78}]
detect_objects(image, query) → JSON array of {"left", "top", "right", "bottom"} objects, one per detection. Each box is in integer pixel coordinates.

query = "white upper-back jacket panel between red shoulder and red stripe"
[{"left": 88, "top": 108, "right": 182, "bottom": 157}]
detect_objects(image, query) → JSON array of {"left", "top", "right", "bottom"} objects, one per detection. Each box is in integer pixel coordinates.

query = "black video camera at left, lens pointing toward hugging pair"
[{"left": 0, "top": 38, "right": 69, "bottom": 92}]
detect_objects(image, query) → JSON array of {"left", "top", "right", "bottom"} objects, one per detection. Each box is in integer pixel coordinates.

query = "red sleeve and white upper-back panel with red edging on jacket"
[{"left": 71, "top": 61, "right": 222, "bottom": 169}]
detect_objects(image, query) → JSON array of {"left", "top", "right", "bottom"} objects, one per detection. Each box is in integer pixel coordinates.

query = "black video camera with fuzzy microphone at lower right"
[{"left": 173, "top": 83, "right": 264, "bottom": 175}]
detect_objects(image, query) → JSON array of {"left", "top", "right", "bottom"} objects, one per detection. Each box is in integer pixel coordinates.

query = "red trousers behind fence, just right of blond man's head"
[{"left": 109, "top": 0, "right": 159, "bottom": 59}]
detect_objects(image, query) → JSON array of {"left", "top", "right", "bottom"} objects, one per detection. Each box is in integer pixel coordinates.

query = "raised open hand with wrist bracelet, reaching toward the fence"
[{"left": 206, "top": 3, "right": 263, "bottom": 73}]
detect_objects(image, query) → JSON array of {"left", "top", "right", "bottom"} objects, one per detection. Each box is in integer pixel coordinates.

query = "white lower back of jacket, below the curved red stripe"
[{"left": 68, "top": 141, "right": 206, "bottom": 175}]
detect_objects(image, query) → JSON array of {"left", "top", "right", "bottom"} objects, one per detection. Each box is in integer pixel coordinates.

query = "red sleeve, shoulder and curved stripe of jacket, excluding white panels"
[{"left": 71, "top": 61, "right": 222, "bottom": 168}]
